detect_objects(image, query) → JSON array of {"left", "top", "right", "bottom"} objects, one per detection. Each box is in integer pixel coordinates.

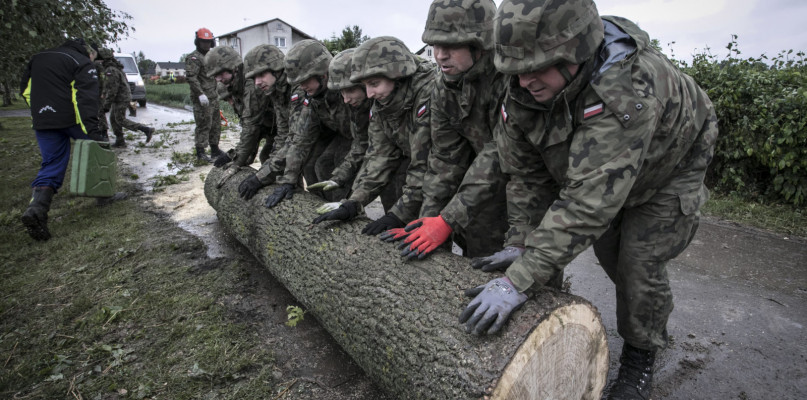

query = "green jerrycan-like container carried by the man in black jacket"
[{"left": 70, "top": 140, "right": 118, "bottom": 197}]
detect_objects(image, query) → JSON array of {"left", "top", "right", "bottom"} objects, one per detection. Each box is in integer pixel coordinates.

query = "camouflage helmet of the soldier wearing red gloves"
[{"left": 422, "top": 0, "right": 496, "bottom": 50}]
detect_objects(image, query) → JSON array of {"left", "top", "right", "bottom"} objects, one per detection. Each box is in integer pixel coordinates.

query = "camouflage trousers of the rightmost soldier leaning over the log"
[{"left": 594, "top": 187, "right": 708, "bottom": 350}]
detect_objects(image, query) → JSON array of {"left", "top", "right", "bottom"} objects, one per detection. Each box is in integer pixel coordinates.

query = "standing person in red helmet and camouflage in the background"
[{"left": 185, "top": 28, "right": 224, "bottom": 162}]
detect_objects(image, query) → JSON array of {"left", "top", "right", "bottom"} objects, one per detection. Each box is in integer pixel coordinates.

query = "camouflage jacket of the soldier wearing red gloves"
[{"left": 420, "top": 53, "right": 507, "bottom": 229}]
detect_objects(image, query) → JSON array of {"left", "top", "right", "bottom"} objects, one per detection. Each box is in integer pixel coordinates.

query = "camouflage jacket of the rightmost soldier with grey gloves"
[{"left": 495, "top": 17, "right": 717, "bottom": 292}]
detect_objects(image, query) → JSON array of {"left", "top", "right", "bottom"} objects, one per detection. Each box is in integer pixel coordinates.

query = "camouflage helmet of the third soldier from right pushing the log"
[{"left": 350, "top": 36, "right": 417, "bottom": 83}]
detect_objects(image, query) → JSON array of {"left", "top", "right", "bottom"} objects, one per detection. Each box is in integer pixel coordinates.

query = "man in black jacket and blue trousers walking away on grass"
[{"left": 20, "top": 38, "right": 108, "bottom": 240}]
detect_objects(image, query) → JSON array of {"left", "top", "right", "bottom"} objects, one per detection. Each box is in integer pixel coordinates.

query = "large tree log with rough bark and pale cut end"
[{"left": 205, "top": 168, "right": 608, "bottom": 399}]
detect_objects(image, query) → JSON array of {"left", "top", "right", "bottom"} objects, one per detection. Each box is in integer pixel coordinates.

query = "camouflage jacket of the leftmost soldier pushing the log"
[{"left": 229, "top": 64, "right": 274, "bottom": 167}]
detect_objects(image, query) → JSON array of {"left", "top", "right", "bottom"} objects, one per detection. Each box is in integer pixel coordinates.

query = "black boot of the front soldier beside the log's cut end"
[{"left": 603, "top": 343, "right": 656, "bottom": 400}]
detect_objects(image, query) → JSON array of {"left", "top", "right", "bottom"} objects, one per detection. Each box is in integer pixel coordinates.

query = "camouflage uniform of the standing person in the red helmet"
[{"left": 185, "top": 49, "right": 221, "bottom": 152}]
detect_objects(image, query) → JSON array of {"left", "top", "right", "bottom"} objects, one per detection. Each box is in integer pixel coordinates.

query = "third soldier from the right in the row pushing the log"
[{"left": 314, "top": 36, "right": 436, "bottom": 235}]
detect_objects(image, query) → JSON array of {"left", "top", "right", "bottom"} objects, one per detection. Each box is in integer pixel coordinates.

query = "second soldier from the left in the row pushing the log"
[{"left": 238, "top": 44, "right": 304, "bottom": 200}]
